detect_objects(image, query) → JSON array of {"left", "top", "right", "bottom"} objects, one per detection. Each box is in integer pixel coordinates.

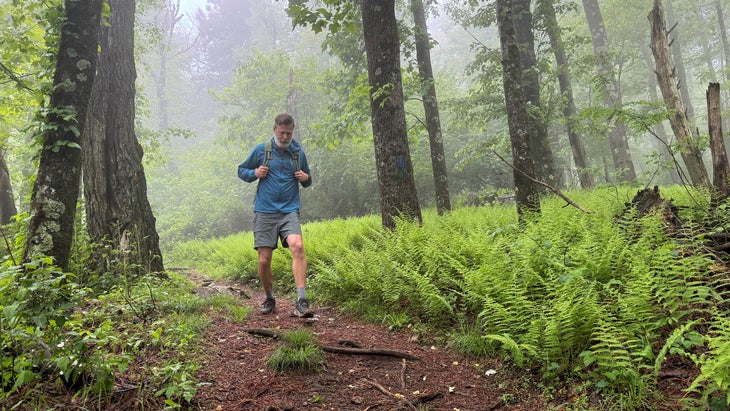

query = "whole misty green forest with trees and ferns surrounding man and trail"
[{"left": 0, "top": 0, "right": 730, "bottom": 410}]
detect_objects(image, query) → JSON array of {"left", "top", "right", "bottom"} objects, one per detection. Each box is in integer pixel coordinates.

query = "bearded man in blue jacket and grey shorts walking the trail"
[{"left": 238, "top": 114, "right": 313, "bottom": 318}]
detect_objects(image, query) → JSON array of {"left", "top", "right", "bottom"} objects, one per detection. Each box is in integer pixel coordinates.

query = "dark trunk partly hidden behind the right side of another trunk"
[{"left": 511, "top": 0, "right": 561, "bottom": 189}]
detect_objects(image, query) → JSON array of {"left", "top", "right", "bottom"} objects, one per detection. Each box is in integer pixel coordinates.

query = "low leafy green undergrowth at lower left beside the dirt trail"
[{"left": 0, "top": 246, "right": 248, "bottom": 410}]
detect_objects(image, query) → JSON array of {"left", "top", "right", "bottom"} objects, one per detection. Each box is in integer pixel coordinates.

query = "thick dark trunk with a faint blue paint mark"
[{"left": 360, "top": 0, "right": 423, "bottom": 229}]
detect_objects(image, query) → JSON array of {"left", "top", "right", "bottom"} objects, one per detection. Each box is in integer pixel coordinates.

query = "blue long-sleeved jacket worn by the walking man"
[{"left": 238, "top": 137, "right": 312, "bottom": 214}]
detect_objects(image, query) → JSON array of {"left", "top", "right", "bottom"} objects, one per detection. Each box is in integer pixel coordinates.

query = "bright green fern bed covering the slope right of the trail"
[{"left": 168, "top": 188, "right": 730, "bottom": 409}]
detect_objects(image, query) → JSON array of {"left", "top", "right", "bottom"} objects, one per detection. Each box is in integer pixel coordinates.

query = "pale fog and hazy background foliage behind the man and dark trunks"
[{"left": 137, "top": 0, "right": 724, "bottom": 249}]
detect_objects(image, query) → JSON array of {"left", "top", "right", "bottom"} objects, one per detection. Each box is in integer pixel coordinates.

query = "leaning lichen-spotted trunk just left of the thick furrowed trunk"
[{"left": 23, "top": 0, "right": 103, "bottom": 271}]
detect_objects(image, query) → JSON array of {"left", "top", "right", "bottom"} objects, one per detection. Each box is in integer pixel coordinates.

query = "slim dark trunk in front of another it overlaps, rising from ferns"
[{"left": 497, "top": 0, "right": 540, "bottom": 222}]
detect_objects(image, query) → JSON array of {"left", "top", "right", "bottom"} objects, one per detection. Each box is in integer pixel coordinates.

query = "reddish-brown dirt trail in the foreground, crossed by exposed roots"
[{"left": 193, "top": 278, "right": 547, "bottom": 411}]
